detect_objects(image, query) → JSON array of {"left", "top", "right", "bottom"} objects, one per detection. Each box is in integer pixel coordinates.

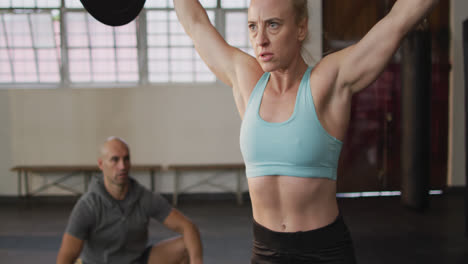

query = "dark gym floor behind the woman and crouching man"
[{"left": 0, "top": 191, "right": 468, "bottom": 264}]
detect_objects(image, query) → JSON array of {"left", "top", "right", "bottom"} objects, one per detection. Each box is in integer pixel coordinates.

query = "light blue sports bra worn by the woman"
[{"left": 240, "top": 67, "right": 343, "bottom": 180}]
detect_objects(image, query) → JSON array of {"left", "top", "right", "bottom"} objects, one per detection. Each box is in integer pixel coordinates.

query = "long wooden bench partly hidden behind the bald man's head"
[{"left": 11, "top": 165, "right": 161, "bottom": 197}]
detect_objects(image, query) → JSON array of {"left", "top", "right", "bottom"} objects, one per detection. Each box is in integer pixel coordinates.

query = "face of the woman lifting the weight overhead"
[{"left": 248, "top": 0, "right": 307, "bottom": 72}]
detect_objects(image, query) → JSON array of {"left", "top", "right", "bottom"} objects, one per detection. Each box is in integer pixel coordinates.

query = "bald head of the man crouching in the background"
[{"left": 98, "top": 137, "right": 131, "bottom": 186}]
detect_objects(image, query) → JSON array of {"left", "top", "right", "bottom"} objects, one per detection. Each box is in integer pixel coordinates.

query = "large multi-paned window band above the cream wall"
[{"left": 0, "top": 0, "right": 252, "bottom": 87}]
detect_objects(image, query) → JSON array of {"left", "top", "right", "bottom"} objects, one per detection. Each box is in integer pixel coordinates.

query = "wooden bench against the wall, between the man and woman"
[{"left": 167, "top": 164, "right": 245, "bottom": 206}]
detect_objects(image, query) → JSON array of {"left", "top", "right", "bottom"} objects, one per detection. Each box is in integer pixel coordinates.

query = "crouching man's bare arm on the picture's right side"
[{"left": 163, "top": 209, "right": 203, "bottom": 264}]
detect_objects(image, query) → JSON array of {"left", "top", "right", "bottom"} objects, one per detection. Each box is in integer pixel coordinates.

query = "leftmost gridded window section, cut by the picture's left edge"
[{"left": 0, "top": 12, "right": 60, "bottom": 84}]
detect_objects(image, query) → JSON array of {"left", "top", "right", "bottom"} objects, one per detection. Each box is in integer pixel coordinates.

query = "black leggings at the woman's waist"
[{"left": 251, "top": 215, "right": 356, "bottom": 264}]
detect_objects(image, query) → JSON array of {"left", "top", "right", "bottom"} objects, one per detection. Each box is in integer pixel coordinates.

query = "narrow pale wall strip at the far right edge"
[{"left": 447, "top": 0, "right": 468, "bottom": 186}]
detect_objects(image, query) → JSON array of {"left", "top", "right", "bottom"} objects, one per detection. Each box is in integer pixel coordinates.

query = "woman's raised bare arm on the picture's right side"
[{"left": 329, "top": 0, "right": 438, "bottom": 94}]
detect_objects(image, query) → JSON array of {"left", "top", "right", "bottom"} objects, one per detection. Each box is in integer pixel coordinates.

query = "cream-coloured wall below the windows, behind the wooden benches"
[{"left": 0, "top": 84, "right": 247, "bottom": 195}]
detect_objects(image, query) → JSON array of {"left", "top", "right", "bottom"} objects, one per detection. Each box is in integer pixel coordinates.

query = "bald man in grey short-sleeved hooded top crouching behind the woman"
[{"left": 57, "top": 137, "right": 202, "bottom": 264}]
